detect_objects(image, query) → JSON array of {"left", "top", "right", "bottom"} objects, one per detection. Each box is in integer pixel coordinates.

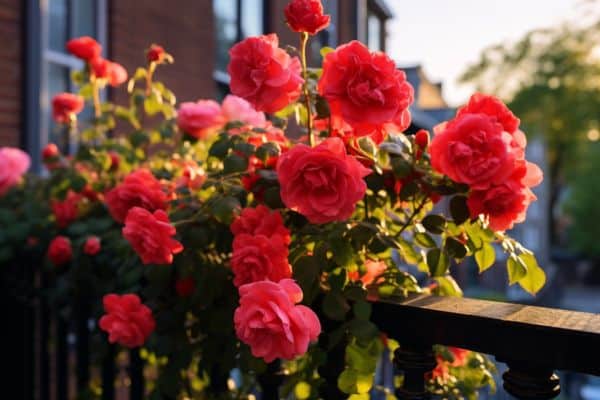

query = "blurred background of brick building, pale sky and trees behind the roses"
[{"left": 0, "top": 0, "right": 600, "bottom": 399}]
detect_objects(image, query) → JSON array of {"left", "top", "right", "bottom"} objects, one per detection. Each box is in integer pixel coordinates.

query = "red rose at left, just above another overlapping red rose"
[{"left": 106, "top": 168, "right": 168, "bottom": 222}]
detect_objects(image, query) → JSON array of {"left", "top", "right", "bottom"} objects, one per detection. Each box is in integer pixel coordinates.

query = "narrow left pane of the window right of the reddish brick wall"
[{"left": 213, "top": 0, "right": 237, "bottom": 71}]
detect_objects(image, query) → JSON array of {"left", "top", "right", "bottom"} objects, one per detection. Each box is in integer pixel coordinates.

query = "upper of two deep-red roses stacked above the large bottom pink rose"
[{"left": 231, "top": 205, "right": 290, "bottom": 245}]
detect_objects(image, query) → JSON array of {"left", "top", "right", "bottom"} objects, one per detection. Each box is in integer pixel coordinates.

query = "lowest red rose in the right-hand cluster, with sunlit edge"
[{"left": 467, "top": 162, "right": 542, "bottom": 231}]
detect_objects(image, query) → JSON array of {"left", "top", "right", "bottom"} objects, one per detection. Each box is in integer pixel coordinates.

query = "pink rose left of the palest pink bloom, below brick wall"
[{"left": 177, "top": 100, "right": 225, "bottom": 139}]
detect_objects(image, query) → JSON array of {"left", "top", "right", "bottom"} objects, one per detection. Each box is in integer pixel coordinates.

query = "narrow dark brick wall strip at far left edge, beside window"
[{"left": 0, "top": 0, "right": 23, "bottom": 146}]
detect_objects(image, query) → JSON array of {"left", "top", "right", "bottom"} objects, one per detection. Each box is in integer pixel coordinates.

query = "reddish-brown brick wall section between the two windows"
[{"left": 109, "top": 0, "right": 216, "bottom": 102}]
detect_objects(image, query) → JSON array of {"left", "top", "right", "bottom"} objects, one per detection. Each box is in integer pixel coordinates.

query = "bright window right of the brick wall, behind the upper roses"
[{"left": 213, "top": 0, "right": 265, "bottom": 97}]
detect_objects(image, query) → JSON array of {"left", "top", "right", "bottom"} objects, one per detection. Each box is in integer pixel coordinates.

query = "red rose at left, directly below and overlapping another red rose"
[{"left": 123, "top": 207, "right": 183, "bottom": 264}]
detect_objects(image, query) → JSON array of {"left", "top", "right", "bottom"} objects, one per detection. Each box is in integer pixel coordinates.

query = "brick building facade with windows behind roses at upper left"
[{"left": 0, "top": 0, "right": 392, "bottom": 169}]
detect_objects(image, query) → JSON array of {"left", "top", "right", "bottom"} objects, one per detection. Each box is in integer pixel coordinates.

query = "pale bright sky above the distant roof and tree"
[{"left": 386, "top": 0, "right": 582, "bottom": 106}]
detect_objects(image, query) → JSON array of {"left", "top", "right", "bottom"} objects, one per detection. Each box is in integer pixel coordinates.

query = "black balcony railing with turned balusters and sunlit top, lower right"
[{"left": 373, "top": 295, "right": 600, "bottom": 399}]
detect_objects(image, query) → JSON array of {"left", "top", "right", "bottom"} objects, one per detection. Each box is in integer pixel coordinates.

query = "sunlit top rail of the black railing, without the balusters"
[{"left": 373, "top": 295, "right": 600, "bottom": 376}]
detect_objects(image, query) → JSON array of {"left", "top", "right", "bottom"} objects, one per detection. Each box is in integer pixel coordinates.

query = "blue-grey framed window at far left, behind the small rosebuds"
[{"left": 40, "top": 0, "right": 105, "bottom": 152}]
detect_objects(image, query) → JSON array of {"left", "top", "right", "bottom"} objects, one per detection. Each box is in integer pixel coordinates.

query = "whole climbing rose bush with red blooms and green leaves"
[{"left": 0, "top": 0, "right": 545, "bottom": 399}]
